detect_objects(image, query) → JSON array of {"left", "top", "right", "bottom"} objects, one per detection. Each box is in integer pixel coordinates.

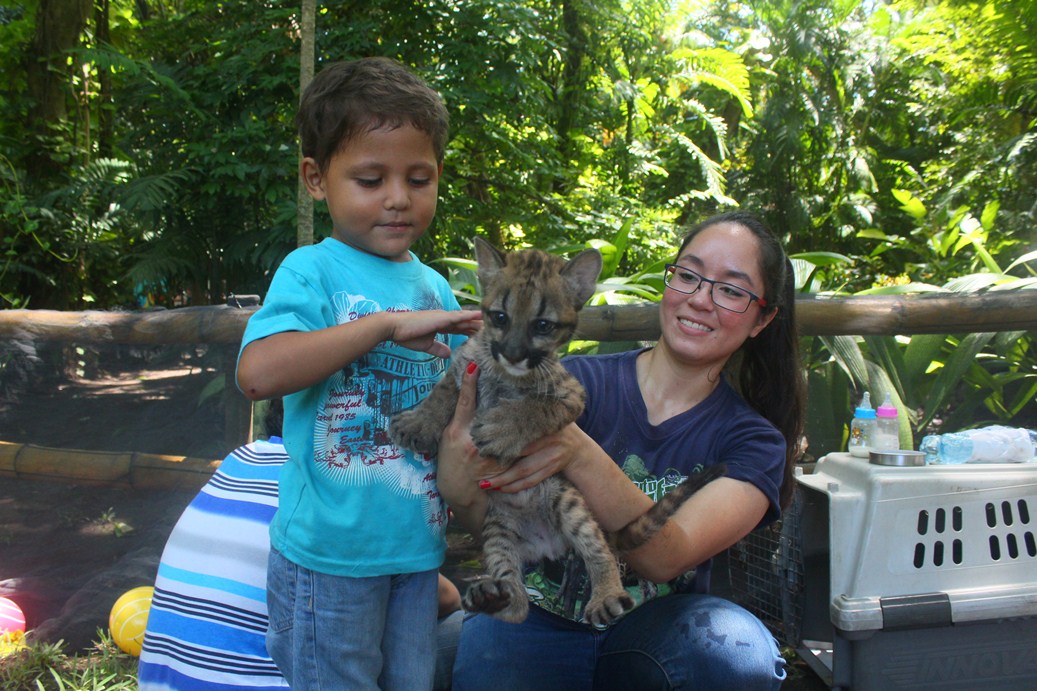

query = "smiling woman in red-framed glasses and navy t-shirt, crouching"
[{"left": 439, "top": 213, "right": 804, "bottom": 691}]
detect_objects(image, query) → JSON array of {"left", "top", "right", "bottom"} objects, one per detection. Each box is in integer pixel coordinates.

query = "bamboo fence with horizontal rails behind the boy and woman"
[{"left": 0, "top": 291, "right": 1037, "bottom": 490}]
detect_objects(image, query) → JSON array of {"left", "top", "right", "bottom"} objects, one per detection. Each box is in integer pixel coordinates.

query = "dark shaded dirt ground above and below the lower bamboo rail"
[{"left": 0, "top": 349, "right": 223, "bottom": 648}]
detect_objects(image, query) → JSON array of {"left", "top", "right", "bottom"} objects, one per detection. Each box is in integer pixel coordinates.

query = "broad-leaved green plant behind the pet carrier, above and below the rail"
[{"left": 793, "top": 191, "right": 1037, "bottom": 455}]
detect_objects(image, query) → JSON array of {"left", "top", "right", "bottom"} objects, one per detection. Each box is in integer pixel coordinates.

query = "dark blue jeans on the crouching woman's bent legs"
[{"left": 453, "top": 595, "right": 785, "bottom": 691}]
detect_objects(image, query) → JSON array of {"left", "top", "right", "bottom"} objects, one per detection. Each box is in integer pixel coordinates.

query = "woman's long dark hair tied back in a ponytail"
[{"left": 677, "top": 207, "right": 807, "bottom": 508}]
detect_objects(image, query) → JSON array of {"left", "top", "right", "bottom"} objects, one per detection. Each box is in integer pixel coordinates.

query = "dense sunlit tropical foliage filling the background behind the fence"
[{"left": 0, "top": 0, "right": 1037, "bottom": 450}]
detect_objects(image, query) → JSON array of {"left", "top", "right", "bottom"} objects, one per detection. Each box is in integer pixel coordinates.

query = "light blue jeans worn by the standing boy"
[{"left": 267, "top": 549, "right": 437, "bottom": 691}]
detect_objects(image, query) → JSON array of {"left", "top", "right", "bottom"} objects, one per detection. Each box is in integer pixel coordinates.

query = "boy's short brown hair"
[{"left": 296, "top": 57, "right": 450, "bottom": 171}]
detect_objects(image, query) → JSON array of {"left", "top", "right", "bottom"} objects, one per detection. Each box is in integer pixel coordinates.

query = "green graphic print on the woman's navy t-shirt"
[{"left": 518, "top": 454, "right": 702, "bottom": 621}]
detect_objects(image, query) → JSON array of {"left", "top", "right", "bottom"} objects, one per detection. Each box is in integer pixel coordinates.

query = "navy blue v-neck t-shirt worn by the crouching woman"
[{"left": 526, "top": 351, "right": 785, "bottom": 621}]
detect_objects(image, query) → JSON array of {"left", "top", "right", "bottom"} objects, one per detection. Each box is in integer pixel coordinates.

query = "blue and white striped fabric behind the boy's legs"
[{"left": 138, "top": 437, "right": 288, "bottom": 691}]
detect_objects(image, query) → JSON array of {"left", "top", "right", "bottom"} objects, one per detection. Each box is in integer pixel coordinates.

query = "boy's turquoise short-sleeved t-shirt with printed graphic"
[{"left": 242, "top": 238, "right": 464, "bottom": 578}]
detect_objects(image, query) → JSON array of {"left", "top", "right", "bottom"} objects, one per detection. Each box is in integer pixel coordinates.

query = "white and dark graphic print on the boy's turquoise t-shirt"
[{"left": 313, "top": 286, "right": 446, "bottom": 504}]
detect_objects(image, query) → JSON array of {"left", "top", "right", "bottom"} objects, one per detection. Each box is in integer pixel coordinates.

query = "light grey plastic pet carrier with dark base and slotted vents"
[{"left": 728, "top": 453, "right": 1037, "bottom": 691}]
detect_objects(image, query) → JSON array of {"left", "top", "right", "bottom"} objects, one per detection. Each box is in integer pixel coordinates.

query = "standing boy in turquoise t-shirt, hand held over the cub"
[{"left": 237, "top": 58, "right": 480, "bottom": 691}]
